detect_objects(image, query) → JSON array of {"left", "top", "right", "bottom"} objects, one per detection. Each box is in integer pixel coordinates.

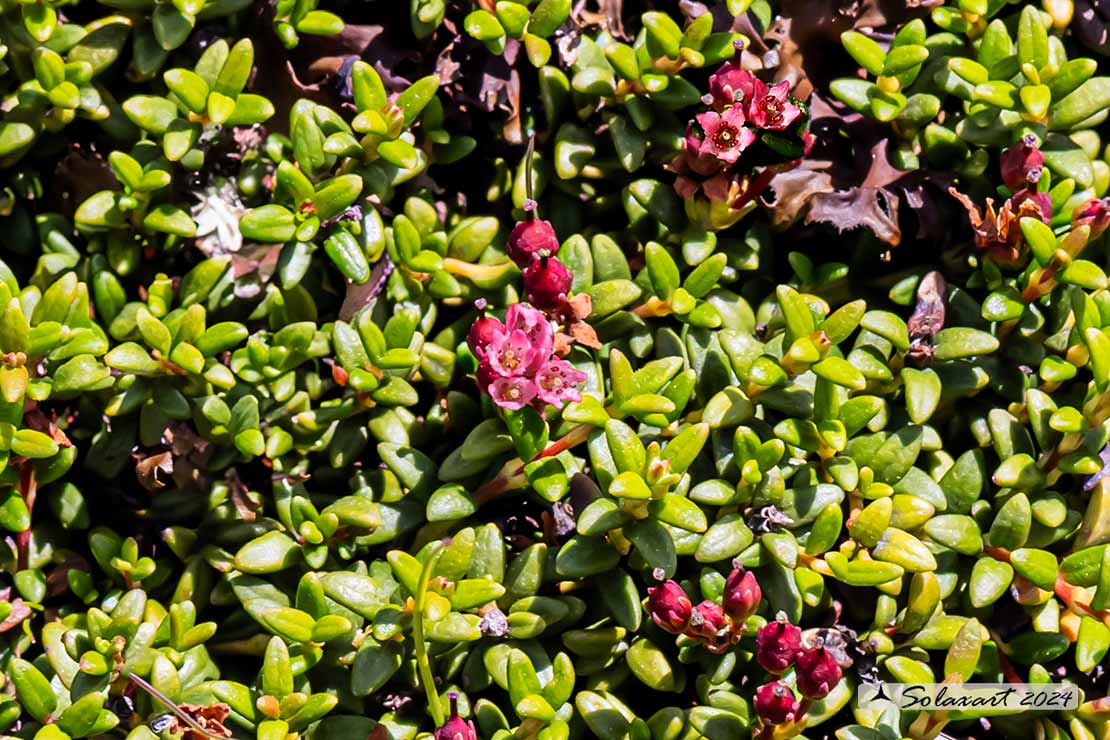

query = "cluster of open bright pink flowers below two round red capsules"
[{"left": 466, "top": 302, "right": 586, "bottom": 410}]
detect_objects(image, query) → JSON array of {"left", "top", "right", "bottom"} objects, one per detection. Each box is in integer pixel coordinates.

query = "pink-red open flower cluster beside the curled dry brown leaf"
[{"left": 669, "top": 45, "right": 810, "bottom": 219}]
